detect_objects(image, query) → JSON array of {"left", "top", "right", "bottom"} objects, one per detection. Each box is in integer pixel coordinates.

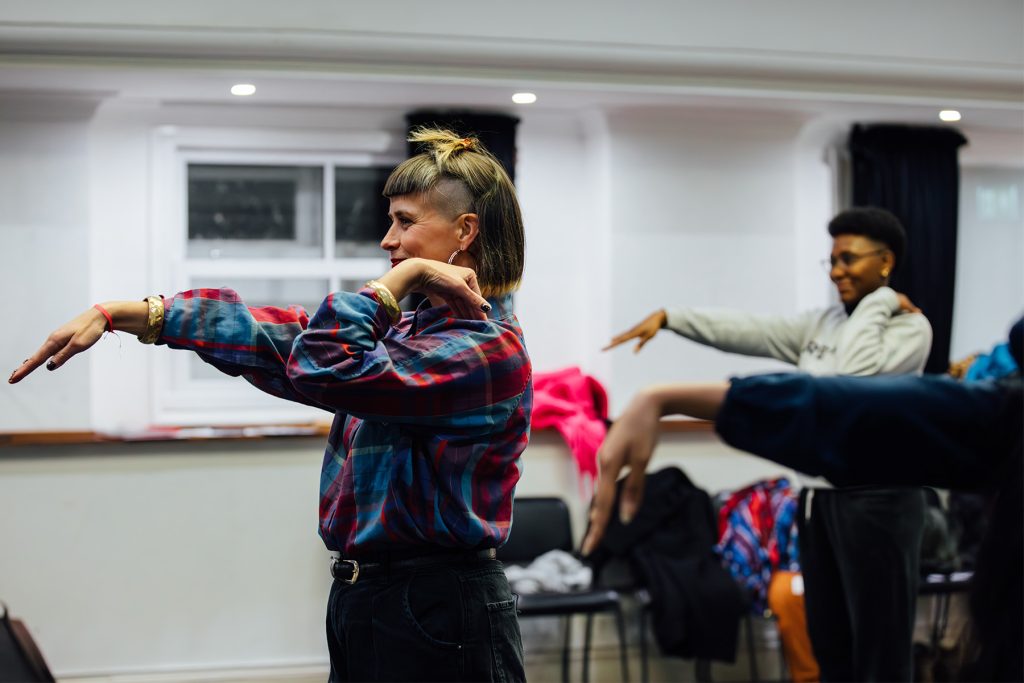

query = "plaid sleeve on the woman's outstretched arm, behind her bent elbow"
[{"left": 158, "top": 289, "right": 332, "bottom": 410}]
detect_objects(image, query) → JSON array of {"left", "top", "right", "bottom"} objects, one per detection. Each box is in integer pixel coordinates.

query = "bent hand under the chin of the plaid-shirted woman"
[{"left": 377, "top": 258, "right": 490, "bottom": 321}]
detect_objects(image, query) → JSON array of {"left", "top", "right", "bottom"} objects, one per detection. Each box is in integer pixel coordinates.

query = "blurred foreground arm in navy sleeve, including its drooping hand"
[{"left": 583, "top": 374, "right": 1024, "bottom": 554}]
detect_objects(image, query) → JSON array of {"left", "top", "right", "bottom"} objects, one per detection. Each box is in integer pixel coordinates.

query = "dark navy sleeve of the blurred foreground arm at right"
[{"left": 716, "top": 374, "right": 1022, "bottom": 488}]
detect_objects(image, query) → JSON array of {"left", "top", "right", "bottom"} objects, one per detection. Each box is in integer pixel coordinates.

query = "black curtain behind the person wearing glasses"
[{"left": 849, "top": 125, "right": 967, "bottom": 373}]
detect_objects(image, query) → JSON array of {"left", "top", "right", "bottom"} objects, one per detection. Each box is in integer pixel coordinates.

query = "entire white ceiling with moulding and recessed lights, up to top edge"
[{"left": 0, "top": 0, "right": 1024, "bottom": 131}]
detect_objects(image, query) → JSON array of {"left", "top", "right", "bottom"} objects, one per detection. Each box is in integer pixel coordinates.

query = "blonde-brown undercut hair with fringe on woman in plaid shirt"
[{"left": 384, "top": 128, "right": 526, "bottom": 297}]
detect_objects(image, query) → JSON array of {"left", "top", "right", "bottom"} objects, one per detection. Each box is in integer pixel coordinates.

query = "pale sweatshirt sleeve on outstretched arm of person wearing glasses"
[{"left": 666, "top": 308, "right": 814, "bottom": 365}]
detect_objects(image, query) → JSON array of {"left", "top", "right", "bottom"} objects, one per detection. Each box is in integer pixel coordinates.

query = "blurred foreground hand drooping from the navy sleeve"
[{"left": 583, "top": 391, "right": 662, "bottom": 555}]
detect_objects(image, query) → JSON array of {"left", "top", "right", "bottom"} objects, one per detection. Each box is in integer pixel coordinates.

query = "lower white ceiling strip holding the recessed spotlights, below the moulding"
[{"left": 0, "top": 58, "right": 1024, "bottom": 130}]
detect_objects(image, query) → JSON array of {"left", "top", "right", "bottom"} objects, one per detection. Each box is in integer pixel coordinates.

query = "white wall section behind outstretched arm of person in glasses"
[{"left": 609, "top": 110, "right": 802, "bottom": 410}]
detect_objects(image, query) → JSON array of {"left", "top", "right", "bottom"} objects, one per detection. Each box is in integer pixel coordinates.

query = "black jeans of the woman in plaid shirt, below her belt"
[{"left": 327, "top": 560, "right": 526, "bottom": 683}]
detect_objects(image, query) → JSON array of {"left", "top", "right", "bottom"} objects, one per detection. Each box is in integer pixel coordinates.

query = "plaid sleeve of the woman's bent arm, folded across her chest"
[{"left": 288, "top": 290, "right": 530, "bottom": 432}]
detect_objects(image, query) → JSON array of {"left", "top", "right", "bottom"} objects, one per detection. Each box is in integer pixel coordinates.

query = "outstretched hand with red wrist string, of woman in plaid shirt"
[{"left": 7, "top": 301, "right": 148, "bottom": 384}]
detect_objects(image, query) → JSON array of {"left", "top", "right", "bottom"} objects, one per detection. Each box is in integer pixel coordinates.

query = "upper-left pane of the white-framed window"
[{"left": 188, "top": 164, "right": 324, "bottom": 258}]
